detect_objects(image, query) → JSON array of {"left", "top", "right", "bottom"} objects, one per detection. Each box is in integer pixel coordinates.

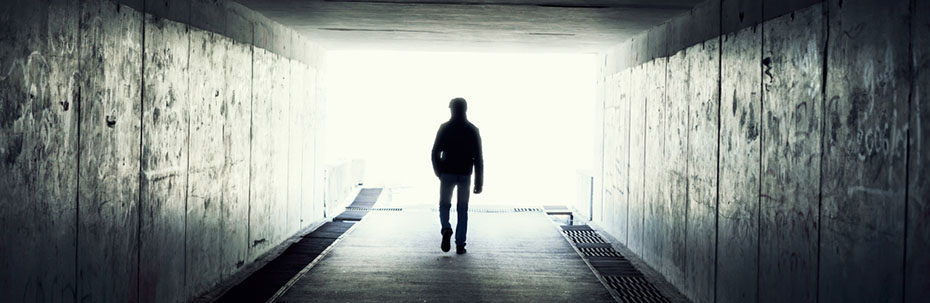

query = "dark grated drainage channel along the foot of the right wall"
[{"left": 561, "top": 225, "right": 672, "bottom": 303}]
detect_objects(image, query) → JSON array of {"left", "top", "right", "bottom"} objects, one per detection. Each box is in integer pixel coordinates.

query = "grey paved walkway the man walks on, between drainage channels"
[{"left": 277, "top": 209, "right": 614, "bottom": 302}]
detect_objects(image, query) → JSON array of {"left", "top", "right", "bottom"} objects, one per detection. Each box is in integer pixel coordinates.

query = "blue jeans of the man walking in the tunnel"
[{"left": 439, "top": 174, "right": 471, "bottom": 245}]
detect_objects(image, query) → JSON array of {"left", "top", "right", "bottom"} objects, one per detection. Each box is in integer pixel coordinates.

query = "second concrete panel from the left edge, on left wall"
[{"left": 76, "top": 1, "right": 143, "bottom": 302}]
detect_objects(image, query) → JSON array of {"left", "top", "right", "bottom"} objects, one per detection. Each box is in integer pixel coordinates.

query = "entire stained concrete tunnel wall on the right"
[{"left": 594, "top": 0, "right": 930, "bottom": 302}]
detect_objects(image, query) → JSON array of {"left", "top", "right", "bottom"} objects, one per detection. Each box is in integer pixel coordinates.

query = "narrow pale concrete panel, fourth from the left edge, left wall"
[{"left": 185, "top": 29, "right": 229, "bottom": 296}]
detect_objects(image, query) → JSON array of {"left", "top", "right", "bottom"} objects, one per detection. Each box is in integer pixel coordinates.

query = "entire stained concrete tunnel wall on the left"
[{"left": 0, "top": 0, "right": 323, "bottom": 302}]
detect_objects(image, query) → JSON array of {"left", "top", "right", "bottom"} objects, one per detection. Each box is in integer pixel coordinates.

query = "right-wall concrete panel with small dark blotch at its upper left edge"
[{"left": 758, "top": 6, "right": 825, "bottom": 302}]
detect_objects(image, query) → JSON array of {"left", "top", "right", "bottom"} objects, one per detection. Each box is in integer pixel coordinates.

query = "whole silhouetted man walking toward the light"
[{"left": 432, "top": 98, "right": 484, "bottom": 254}]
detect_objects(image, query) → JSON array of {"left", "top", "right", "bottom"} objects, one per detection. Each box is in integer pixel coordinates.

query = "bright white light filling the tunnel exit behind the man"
[{"left": 325, "top": 51, "right": 595, "bottom": 205}]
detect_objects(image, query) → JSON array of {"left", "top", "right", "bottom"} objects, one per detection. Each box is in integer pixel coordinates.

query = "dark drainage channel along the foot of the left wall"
[{"left": 215, "top": 188, "right": 380, "bottom": 303}]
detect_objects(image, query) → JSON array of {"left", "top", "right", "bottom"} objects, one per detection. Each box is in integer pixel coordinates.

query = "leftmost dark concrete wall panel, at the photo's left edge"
[{"left": 0, "top": 1, "right": 80, "bottom": 302}]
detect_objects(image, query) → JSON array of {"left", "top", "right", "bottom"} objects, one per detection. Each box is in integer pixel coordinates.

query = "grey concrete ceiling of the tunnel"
[{"left": 237, "top": 0, "right": 703, "bottom": 53}]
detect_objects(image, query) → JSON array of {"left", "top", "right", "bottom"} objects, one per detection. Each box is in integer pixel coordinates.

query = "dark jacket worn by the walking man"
[{"left": 432, "top": 117, "right": 484, "bottom": 188}]
